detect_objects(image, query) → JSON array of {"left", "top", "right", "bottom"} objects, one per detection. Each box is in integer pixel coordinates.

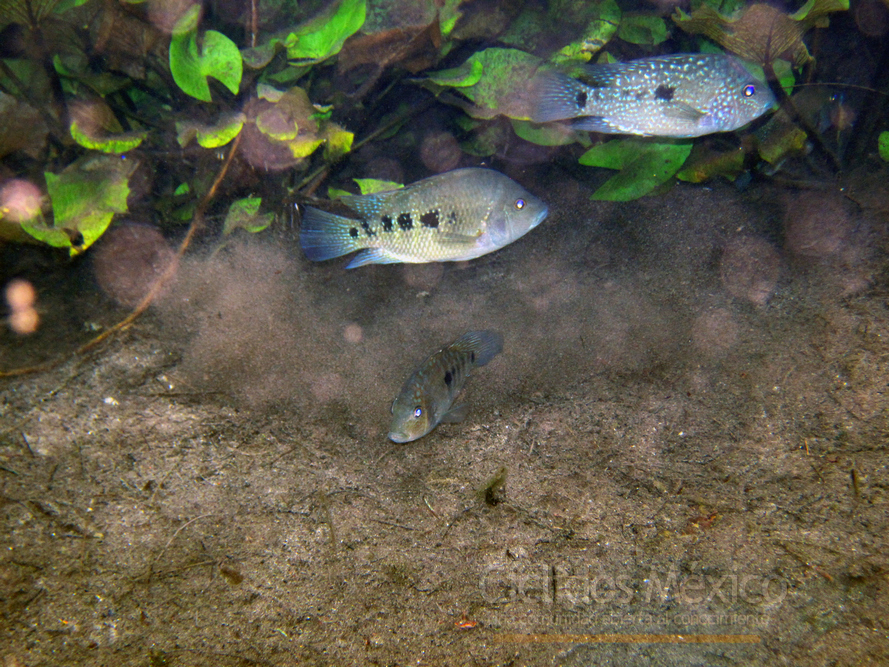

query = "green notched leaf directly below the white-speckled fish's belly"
[{"left": 579, "top": 139, "right": 693, "bottom": 201}]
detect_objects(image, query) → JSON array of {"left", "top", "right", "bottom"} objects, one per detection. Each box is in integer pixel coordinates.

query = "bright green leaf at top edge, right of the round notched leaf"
[{"left": 284, "top": 0, "right": 366, "bottom": 61}]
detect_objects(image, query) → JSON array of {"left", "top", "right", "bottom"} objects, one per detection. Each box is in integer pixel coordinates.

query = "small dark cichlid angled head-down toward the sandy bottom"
[{"left": 389, "top": 331, "right": 503, "bottom": 442}]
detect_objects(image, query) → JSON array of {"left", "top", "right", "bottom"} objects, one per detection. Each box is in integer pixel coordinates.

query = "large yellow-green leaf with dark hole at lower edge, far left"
[{"left": 22, "top": 156, "right": 137, "bottom": 256}]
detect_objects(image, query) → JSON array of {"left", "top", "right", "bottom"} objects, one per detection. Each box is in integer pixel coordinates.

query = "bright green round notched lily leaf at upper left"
[{"left": 170, "top": 11, "right": 243, "bottom": 102}]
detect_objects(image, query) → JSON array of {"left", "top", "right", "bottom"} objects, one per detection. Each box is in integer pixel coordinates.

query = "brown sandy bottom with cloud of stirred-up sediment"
[{"left": 0, "top": 170, "right": 889, "bottom": 667}]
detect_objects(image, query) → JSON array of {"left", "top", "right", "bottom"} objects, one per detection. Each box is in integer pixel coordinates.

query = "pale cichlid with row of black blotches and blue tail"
[{"left": 299, "top": 169, "right": 547, "bottom": 269}]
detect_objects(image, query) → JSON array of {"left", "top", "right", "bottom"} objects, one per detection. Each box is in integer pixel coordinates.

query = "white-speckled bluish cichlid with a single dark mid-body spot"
[{"left": 532, "top": 53, "right": 775, "bottom": 137}]
